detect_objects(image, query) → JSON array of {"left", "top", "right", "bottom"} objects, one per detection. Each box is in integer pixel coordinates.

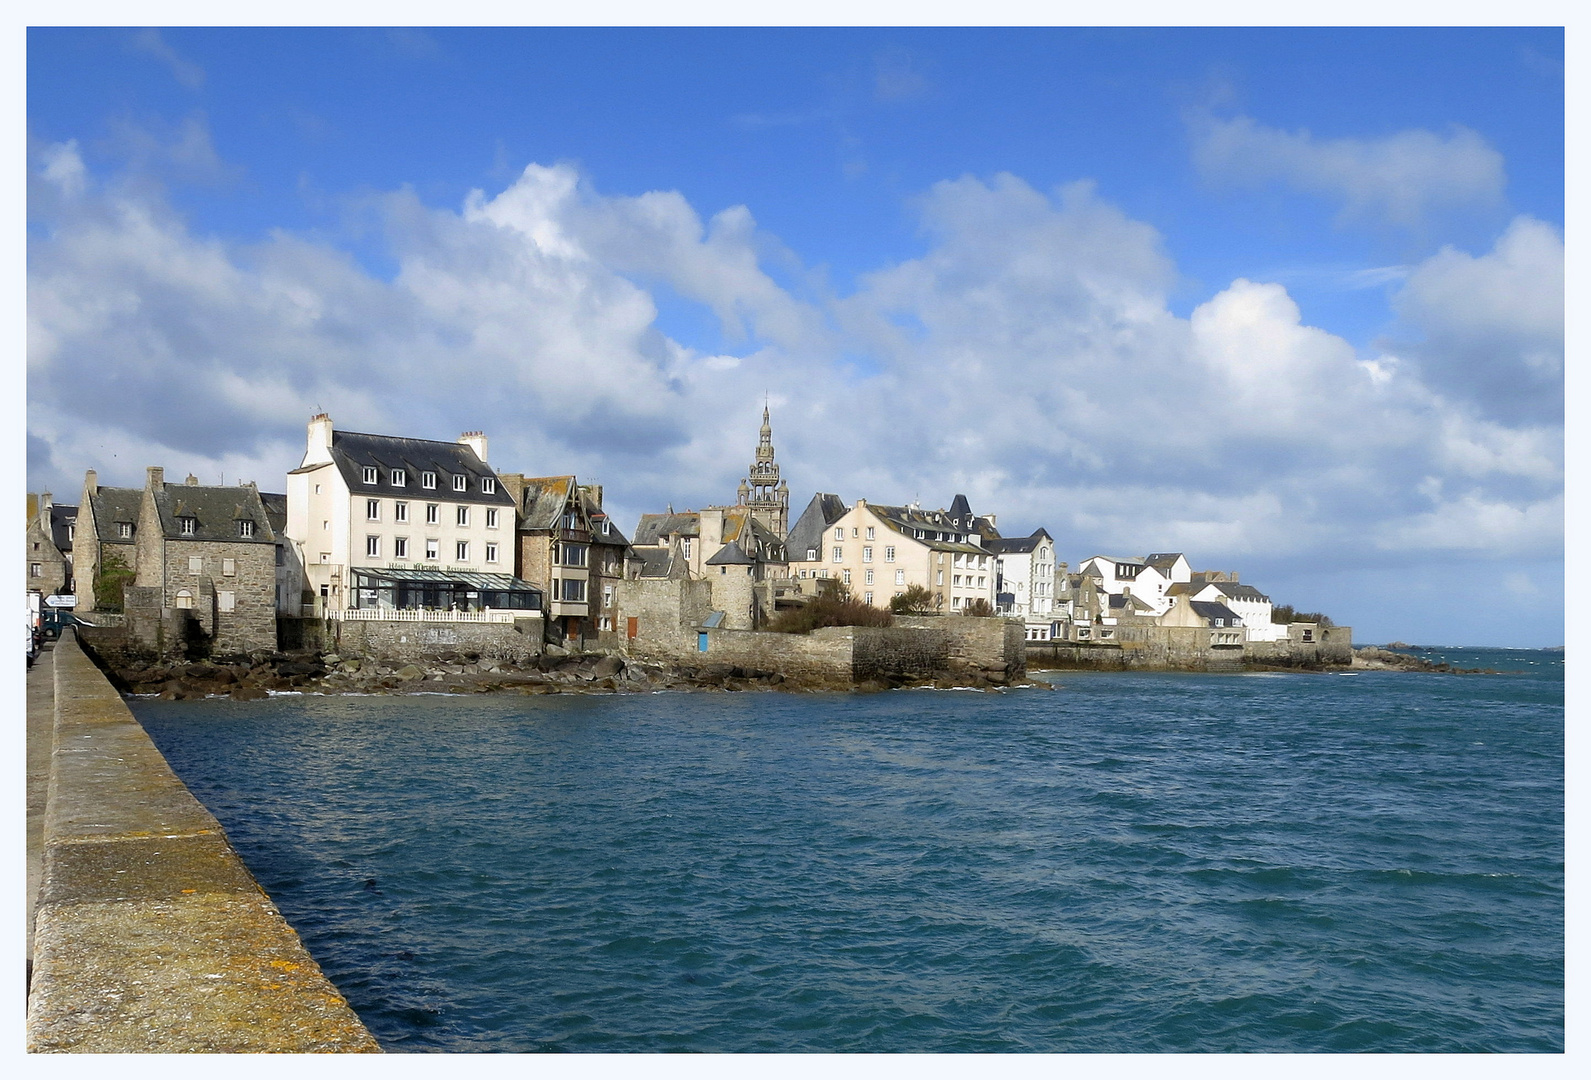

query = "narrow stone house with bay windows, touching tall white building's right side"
[{"left": 501, "top": 472, "right": 630, "bottom": 646}]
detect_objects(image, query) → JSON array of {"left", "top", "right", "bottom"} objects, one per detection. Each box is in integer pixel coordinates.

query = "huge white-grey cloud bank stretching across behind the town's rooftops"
[{"left": 29, "top": 146, "right": 1562, "bottom": 588}]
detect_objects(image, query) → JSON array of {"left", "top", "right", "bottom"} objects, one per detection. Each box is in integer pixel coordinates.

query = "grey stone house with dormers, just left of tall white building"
[{"left": 126, "top": 466, "right": 277, "bottom": 655}]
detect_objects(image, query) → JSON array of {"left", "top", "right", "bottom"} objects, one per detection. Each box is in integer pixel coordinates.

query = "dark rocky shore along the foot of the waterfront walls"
[{"left": 93, "top": 646, "right": 1048, "bottom": 701}]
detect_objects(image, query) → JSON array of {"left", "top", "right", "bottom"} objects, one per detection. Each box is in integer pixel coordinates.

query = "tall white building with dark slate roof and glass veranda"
[{"left": 286, "top": 414, "right": 543, "bottom": 611}]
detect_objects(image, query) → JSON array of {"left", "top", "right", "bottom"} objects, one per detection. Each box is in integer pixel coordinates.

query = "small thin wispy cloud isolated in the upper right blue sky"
[{"left": 1190, "top": 115, "right": 1507, "bottom": 227}]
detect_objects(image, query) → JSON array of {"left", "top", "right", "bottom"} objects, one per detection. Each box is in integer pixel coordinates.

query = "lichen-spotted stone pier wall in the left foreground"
[{"left": 27, "top": 630, "right": 380, "bottom": 1053}]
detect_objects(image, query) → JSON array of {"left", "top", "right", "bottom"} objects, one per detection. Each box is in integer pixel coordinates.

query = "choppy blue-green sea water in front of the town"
[{"left": 134, "top": 651, "right": 1564, "bottom": 1051}]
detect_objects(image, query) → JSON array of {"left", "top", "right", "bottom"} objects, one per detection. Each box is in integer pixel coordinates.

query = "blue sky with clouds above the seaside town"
[{"left": 27, "top": 27, "right": 1564, "bottom": 647}]
